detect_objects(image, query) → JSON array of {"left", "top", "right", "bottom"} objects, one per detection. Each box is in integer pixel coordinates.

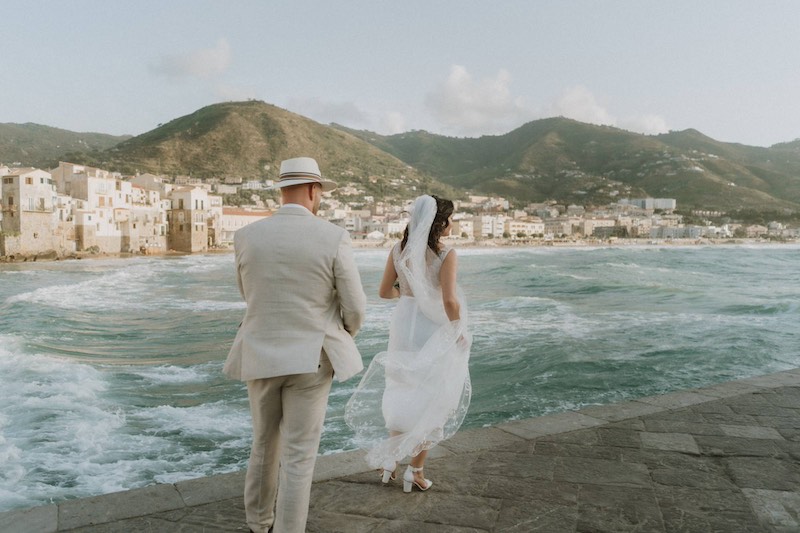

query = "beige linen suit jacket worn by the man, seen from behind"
[{"left": 224, "top": 205, "right": 366, "bottom": 381}]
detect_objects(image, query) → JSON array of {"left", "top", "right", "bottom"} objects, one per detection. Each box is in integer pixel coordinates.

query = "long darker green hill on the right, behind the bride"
[{"left": 337, "top": 117, "right": 800, "bottom": 210}]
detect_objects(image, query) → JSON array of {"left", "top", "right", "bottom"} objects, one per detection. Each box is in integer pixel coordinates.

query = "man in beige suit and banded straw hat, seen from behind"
[{"left": 224, "top": 157, "right": 366, "bottom": 533}]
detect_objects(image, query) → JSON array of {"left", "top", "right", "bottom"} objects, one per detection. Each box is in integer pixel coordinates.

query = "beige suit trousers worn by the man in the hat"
[{"left": 244, "top": 353, "right": 333, "bottom": 533}]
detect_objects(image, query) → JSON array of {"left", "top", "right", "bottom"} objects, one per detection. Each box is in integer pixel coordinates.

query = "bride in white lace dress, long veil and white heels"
[{"left": 345, "top": 195, "right": 471, "bottom": 492}]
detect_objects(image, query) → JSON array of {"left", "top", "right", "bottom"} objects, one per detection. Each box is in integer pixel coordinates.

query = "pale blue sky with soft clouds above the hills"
[{"left": 0, "top": 0, "right": 800, "bottom": 146}]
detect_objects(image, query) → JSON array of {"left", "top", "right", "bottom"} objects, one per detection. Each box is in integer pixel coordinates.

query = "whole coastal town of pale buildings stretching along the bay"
[{"left": 0, "top": 162, "right": 800, "bottom": 261}]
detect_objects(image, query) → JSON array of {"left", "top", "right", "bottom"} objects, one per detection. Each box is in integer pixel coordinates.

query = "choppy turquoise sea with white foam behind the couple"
[{"left": 0, "top": 244, "right": 800, "bottom": 511}]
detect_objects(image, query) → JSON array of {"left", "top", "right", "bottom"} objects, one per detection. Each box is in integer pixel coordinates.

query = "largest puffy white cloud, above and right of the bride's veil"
[{"left": 425, "top": 65, "right": 533, "bottom": 135}]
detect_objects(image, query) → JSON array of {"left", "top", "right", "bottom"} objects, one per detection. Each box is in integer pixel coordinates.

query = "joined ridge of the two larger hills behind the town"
[{"left": 0, "top": 100, "right": 800, "bottom": 212}]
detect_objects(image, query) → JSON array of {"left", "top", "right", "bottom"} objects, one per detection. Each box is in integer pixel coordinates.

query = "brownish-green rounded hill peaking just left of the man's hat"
[{"left": 59, "top": 101, "right": 452, "bottom": 197}]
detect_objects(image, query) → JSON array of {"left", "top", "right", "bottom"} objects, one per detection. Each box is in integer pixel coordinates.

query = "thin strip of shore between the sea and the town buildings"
[{"left": 0, "top": 238, "right": 800, "bottom": 265}]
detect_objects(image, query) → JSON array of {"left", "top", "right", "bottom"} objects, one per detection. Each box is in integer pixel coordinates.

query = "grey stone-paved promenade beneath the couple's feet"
[{"left": 0, "top": 369, "right": 800, "bottom": 533}]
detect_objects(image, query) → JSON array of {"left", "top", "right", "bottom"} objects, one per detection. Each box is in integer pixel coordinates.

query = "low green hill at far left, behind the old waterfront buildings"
[{"left": 0, "top": 122, "right": 130, "bottom": 168}]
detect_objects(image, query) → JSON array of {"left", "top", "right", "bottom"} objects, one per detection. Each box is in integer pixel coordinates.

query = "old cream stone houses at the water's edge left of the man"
[{"left": 0, "top": 162, "right": 269, "bottom": 257}]
